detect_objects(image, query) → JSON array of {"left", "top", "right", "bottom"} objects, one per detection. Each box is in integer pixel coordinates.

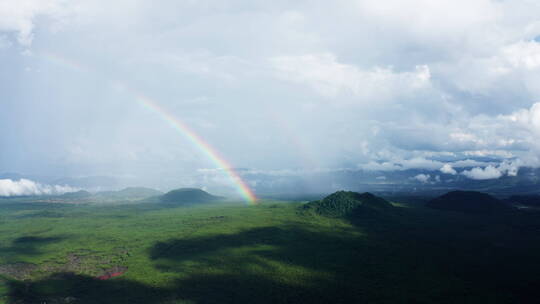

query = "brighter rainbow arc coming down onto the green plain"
[{"left": 40, "top": 53, "right": 257, "bottom": 205}]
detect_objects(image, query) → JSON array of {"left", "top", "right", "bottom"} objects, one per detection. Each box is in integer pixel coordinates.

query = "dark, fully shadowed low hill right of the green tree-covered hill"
[{"left": 427, "top": 191, "right": 513, "bottom": 214}]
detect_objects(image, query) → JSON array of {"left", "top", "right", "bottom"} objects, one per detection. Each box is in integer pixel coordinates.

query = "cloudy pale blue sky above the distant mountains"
[{"left": 0, "top": 0, "right": 540, "bottom": 194}]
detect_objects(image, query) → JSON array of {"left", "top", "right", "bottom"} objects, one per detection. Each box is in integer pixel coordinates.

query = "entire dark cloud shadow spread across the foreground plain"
[{"left": 8, "top": 210, "right": 540, "bottom": 304}]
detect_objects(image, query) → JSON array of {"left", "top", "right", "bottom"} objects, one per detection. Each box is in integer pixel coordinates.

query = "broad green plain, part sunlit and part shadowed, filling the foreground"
[{"left": 0, "top": 192, "right": 540, "bottom": 304}]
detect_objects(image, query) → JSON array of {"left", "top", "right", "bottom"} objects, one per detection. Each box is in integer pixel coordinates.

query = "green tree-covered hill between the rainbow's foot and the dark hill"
[{"left": 303, "top": 191, "right": 394, "bottom": 218}]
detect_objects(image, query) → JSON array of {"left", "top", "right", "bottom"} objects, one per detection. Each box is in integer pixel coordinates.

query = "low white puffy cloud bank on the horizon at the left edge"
[{"left": 0, "top": 179, "right": 80, "bottom": 196}]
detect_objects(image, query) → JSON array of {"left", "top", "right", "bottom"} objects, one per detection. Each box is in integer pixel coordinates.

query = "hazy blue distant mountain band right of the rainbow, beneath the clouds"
[{"left": 251, "top": 167, "right": 540, "bottom": 196}]
